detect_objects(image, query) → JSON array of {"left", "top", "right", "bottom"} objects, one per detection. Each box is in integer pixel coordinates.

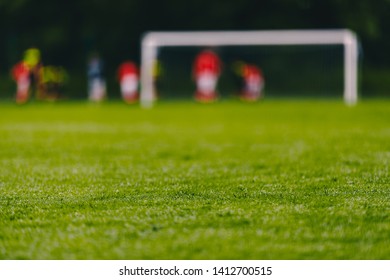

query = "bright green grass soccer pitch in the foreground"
[{"left": 0, "top": 100, "right": 390, "bottom": 259}]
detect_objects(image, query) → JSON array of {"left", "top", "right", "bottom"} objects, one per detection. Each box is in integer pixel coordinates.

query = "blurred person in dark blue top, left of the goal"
[{"left": 87, "top": 53, "right": 106, "bottom": 102}]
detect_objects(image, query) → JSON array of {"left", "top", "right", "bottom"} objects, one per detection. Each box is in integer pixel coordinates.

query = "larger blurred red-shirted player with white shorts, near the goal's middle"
[{"left": 192, "top": 50, "right": 221, "bottom": 102}]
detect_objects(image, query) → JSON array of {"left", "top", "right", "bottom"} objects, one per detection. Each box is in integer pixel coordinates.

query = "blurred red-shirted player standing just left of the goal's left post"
[{"left": 118, "top": 61, "right": 139, "bottom": 103}]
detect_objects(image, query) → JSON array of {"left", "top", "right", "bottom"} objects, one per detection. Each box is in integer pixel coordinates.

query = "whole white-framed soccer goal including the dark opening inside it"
[{"left": 140, "top": 29, "right": 358, "bottom": 107}]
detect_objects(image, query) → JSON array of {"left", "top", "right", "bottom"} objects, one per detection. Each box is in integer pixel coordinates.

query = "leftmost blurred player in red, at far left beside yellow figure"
[{"left": 11, "top": 61, "right": 30, "bottom": 104}]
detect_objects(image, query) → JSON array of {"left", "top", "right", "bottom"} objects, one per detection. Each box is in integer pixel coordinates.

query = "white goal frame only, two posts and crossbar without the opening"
[{"left": 140, "top": 29, "right": 358, "bottom": 107}]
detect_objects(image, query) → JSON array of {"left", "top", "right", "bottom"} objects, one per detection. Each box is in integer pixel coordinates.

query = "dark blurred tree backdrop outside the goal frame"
[{"left": 0, "top": 0, "right": 390, "bottom": 98}]
